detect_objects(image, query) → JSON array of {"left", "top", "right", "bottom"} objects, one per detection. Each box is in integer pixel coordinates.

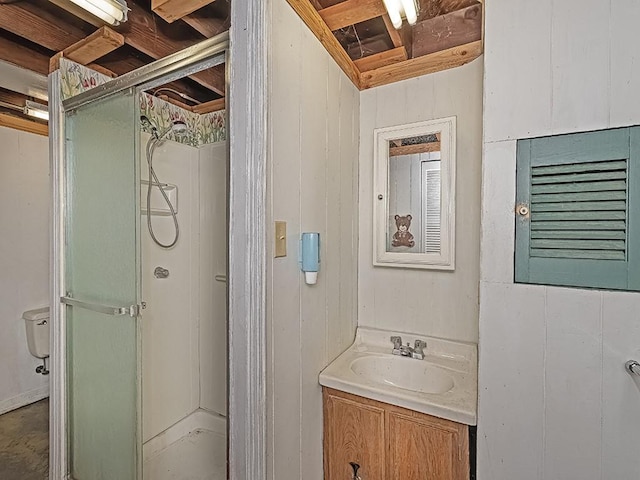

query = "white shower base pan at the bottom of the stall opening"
[{"left": 143, "top": 410, "right": 227, "bottom": 480}]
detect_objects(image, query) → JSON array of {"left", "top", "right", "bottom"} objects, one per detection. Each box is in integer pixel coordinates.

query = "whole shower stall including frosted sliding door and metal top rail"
[{"left": 50, "top": 35, "right": 229, "bottom": 480}]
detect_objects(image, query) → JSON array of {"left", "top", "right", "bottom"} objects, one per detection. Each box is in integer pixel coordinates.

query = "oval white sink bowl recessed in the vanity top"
[{"left": 351, "top": 355, "right": 453, "bottom": 393}]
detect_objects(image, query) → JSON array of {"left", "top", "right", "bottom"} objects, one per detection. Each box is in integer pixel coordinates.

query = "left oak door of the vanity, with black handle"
[{"left": 324, "top": 388, "right": 385, "bottom": 480}]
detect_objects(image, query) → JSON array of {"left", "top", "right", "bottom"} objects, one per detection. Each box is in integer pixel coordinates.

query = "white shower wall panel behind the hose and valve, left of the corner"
[{"left": 141, "top": 137, "right": 200, "bottom": 441}]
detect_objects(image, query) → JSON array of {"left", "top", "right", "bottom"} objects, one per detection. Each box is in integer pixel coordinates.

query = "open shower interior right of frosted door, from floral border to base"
[{"left": 140, "top": 99, "right": 227, "bottom": 480}]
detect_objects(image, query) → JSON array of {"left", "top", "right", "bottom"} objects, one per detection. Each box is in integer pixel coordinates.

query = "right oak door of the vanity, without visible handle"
[{"left": 387, "top": 407, "right": 469, "bottom": 480}]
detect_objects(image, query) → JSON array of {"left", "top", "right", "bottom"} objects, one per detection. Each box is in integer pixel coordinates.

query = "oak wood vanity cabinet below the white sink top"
[{"left": 323, "top": 387, "right": 469, "bottom": 480}]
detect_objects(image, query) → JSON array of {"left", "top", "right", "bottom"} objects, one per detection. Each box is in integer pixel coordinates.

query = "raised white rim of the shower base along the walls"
[{"left": 142, "top": 409, "right": 227, "bottom": 462}]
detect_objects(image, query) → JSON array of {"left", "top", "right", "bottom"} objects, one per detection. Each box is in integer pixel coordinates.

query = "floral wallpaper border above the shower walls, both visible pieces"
[{"left": 60, "top": 58, "right": 227, "bottom": 147}]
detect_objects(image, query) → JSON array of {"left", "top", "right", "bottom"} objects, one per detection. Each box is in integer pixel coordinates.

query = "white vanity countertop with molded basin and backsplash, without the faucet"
[{"left": 318, "top": 327, "right": 478, "bottom": 425}]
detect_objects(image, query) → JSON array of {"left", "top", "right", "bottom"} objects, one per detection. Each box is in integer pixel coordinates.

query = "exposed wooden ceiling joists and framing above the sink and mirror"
[{"left": 287, "top": 0, "right": 483, "bottom": 89}]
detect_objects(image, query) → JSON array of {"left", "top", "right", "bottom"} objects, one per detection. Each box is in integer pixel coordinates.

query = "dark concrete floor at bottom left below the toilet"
[{"left": 0, "top": 399, "right": 49, "bottom": 480}]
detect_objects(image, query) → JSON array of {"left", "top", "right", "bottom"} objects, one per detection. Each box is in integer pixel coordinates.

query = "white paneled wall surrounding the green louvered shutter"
[{"left": 478, "top": 0, "right": 640, "bottom": 480}]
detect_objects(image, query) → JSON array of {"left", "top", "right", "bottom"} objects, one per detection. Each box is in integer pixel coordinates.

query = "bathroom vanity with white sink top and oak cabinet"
[{"left": 319, "top": 327, "right": 477, "bottom": 480}]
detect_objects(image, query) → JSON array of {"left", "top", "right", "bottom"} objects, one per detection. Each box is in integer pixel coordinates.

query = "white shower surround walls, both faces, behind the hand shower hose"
[{"left": 141, "top": 133, "right": 227, "bottom": 441}]
